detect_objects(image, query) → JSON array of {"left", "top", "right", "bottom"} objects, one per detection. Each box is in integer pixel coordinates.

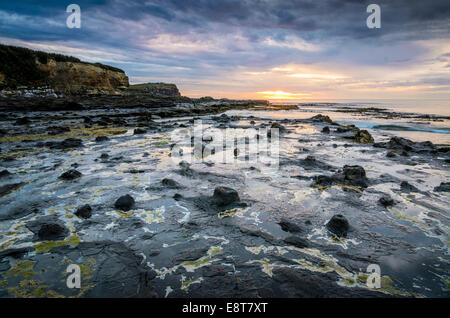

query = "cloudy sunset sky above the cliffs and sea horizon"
[{"left": 0, "top": 0, "right": 450, "bottom": 101}]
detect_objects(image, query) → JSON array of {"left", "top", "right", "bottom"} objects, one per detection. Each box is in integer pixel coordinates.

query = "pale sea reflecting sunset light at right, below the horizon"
[{"left": 228, "top": 99, "right": 450, "bottom": 145}]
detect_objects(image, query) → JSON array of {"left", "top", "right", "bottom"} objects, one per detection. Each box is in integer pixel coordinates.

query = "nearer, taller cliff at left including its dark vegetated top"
[{"left": 0, "top": 45, "right": 129, "bottom": 94}]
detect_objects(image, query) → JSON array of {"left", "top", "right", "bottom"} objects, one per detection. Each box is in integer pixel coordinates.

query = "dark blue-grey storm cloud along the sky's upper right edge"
[{"left": 151, "top": 0, "right": 450, "bottom": 37}]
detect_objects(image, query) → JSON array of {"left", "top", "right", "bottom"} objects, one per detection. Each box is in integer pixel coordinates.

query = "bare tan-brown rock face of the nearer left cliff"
[{"left": 36, "top": 59, "right": 128, "bottom": 94}]
